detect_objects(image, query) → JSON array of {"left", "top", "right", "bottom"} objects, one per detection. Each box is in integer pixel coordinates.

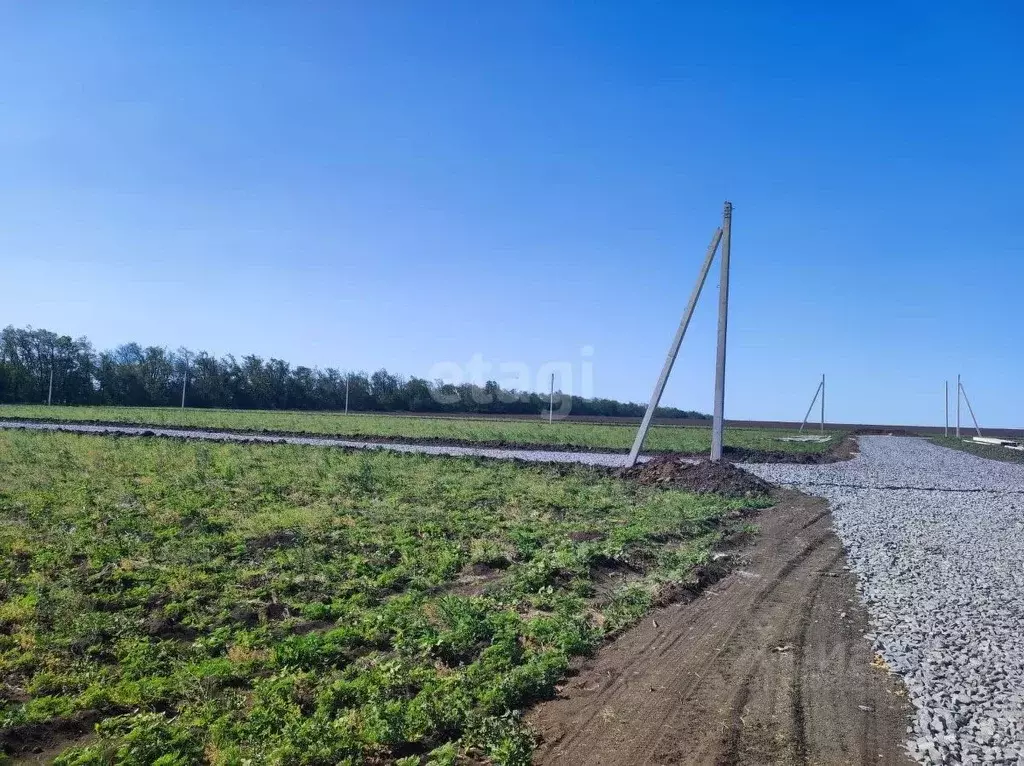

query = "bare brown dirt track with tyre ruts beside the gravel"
[{"left": 530, "top": 491, "right": 910, "bottom": 766}]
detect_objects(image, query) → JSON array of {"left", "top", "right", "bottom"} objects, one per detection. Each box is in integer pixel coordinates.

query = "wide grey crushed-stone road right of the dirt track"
[{"left": 744, "top": 436, "right": 1024, "bottom": 765}]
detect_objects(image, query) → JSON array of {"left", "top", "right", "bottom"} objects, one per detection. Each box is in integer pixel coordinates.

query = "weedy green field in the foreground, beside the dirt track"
[{"left": 0, "top": 434, "right": 764, "bottom": 766}]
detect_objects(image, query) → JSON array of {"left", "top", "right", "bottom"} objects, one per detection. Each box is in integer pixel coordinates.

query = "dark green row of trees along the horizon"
[{"left": 0, "top": 326, "right": 710, "bottom": 418}]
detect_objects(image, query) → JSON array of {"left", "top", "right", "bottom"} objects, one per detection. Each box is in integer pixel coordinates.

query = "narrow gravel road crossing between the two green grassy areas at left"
[{"left": 0, "top": 421, "right": 650, "bottom": 468}]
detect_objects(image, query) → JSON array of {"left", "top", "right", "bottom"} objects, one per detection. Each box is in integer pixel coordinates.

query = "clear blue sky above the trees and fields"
[{"left": 0, "top": 1, "right": 1024, "bottom": 427}]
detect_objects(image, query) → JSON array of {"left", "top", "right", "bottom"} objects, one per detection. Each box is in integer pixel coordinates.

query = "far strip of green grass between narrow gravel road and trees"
[{"left": 0, "top": 405, "right": 830, "bottom": 453}]
